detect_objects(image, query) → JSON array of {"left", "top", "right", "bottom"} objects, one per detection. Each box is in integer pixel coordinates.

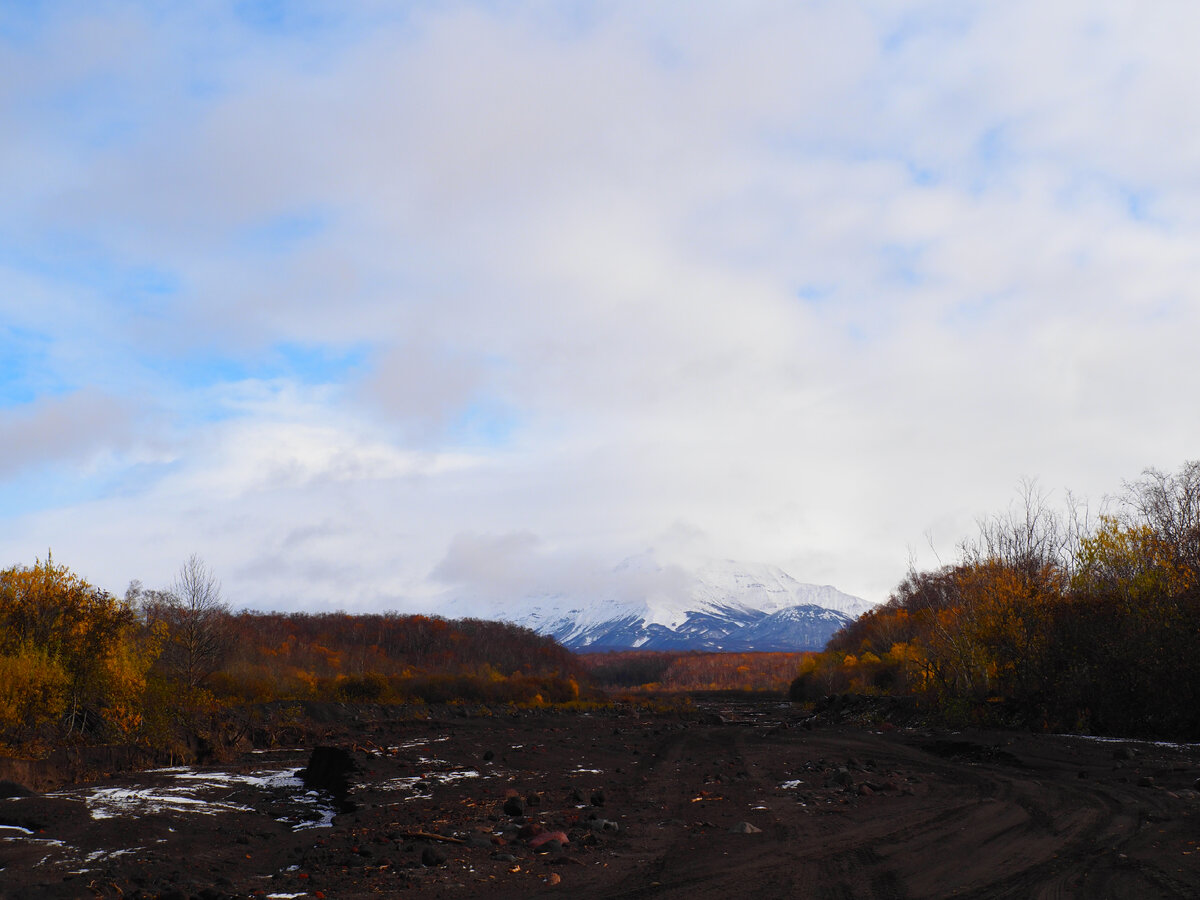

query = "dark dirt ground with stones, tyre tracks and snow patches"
[{"left": 0, "top": 701, "right": 1200, "bottom": 900}]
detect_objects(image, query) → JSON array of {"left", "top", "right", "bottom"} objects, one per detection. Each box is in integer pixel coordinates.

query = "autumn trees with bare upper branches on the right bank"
[{"left": 791, "top": 461, "right": 1200, "bottom": 740}]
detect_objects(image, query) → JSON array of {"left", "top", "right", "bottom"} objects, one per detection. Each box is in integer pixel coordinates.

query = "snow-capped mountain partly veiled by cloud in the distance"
[{"left": 451, "top": 554, "right": 870, "bottom": 650}]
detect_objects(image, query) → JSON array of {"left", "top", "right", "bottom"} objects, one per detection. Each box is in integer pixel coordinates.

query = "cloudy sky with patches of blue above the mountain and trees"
[{"left": 0, "top": 0, "right": 1200, "bottom": 611}]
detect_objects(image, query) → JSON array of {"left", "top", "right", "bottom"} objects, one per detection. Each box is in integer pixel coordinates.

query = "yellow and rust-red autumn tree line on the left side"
[{"left": 0, "top": 554, "right": 586, "bottom": 754}]
